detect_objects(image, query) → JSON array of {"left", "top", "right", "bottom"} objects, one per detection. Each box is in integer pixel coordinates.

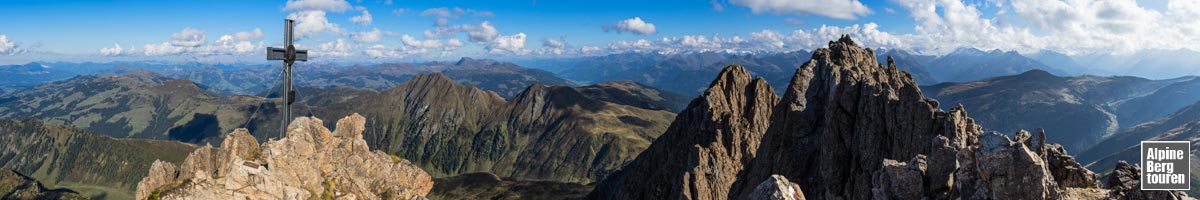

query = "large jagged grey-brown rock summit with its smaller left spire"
[{"left": 589, "top": 36, "right": 1156, "bottom": 199}]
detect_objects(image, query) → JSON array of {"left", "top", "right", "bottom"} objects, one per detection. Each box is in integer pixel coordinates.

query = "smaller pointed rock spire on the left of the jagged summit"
[{"left": 589, "top": 66, "right": 779, "bottom": 199}]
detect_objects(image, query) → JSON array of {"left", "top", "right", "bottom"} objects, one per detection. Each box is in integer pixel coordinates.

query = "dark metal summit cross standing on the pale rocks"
[{"left": 266, "top": 19, "right": 308, "bottom": 138}]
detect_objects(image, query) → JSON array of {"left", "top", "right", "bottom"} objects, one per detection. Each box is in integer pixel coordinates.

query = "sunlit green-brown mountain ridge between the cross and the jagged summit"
[{"left": 314, "top": 74, "right": 674, "bottom": 183}]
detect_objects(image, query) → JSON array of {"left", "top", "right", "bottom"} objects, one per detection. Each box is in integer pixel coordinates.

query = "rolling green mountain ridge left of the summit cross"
[{"left": 0, "top": 71, "right": 278, "bottom": 144}]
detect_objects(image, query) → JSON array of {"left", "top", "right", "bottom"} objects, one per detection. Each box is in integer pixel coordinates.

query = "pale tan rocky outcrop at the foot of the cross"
[{"left": 137, "top": 114, "right": 433, "bottom": 199}]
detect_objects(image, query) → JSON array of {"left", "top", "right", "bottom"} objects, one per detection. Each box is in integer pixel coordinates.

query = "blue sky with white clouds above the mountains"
[{"left": 0, "top": 0, "right": 1200, "bottom": 62}]
